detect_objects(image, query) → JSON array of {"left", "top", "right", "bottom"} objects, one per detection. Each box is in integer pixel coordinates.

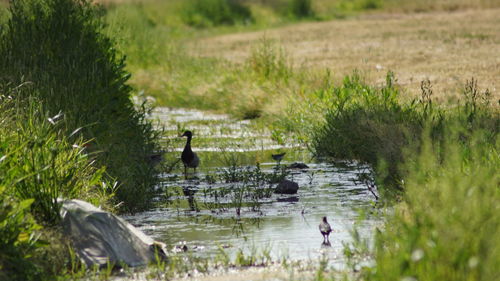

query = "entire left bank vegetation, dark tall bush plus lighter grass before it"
[{"left": 0, "top": 0, "right": 158, "bottom": 280}]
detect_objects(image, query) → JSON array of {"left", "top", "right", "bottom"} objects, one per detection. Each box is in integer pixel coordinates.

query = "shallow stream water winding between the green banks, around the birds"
[{"left": 125, "top": 108, "right": 380, "bottom": 269}]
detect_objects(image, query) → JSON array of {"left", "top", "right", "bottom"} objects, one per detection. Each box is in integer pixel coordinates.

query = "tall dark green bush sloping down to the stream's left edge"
[{"left": 0, "top": 0, "right": 157, "bottom": 211}]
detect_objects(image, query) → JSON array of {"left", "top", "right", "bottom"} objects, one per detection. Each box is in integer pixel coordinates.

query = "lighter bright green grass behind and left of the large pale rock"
[{"left": 0, "top": 94, "right": 114, "bottom": 280}]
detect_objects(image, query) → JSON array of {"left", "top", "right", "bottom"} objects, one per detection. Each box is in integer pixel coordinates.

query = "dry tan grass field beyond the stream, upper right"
[{"left": 190, "top": 9, "right": 500, "bottom": 101}]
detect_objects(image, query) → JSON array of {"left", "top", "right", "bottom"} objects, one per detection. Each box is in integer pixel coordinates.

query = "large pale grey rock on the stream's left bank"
[{"left": 61, "top": 197, "right": 166, "bottom": 267}]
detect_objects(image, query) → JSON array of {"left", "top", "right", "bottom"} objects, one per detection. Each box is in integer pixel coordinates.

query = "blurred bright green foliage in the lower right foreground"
[{"left": 350, "top": 127, "right": 500, "bottom": 281}]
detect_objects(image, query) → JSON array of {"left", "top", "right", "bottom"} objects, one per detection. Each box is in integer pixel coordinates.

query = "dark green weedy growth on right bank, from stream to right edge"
[{"left": 313, "top": 73, "right": 499, "bottom": 190}]
